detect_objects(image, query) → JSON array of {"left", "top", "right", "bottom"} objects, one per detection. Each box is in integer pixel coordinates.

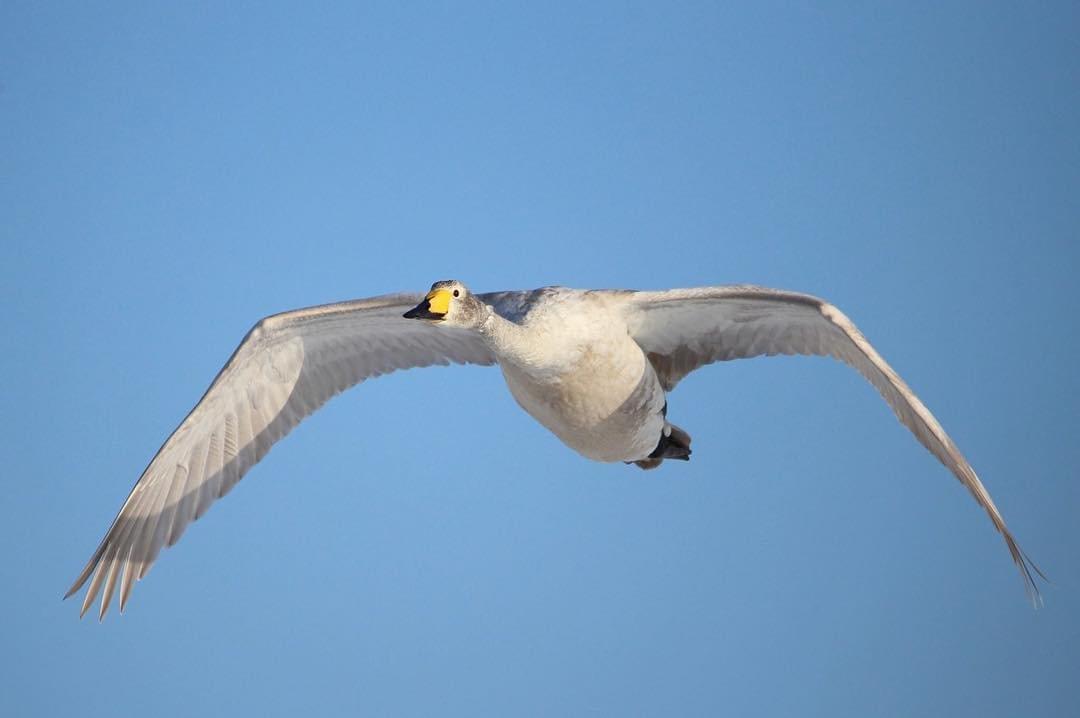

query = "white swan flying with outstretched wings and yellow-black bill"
[{"left": 65, "top": 281, "right": 1042, "bottom": 619}]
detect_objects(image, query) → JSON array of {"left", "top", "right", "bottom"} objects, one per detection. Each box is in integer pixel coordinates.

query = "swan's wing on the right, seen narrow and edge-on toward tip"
[{"left": 612, "top": 285, "right": 1045, "bottom": 602}]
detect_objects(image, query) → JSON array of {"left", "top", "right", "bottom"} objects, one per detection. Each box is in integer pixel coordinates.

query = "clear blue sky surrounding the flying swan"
[{"left": 0, "top": 2, "right": 1080, "bottom": 717}]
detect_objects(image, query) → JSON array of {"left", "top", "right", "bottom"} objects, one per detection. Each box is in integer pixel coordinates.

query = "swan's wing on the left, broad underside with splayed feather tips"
[{"left": 65, "top": 295, "right": 495, "bottom": 619}]
